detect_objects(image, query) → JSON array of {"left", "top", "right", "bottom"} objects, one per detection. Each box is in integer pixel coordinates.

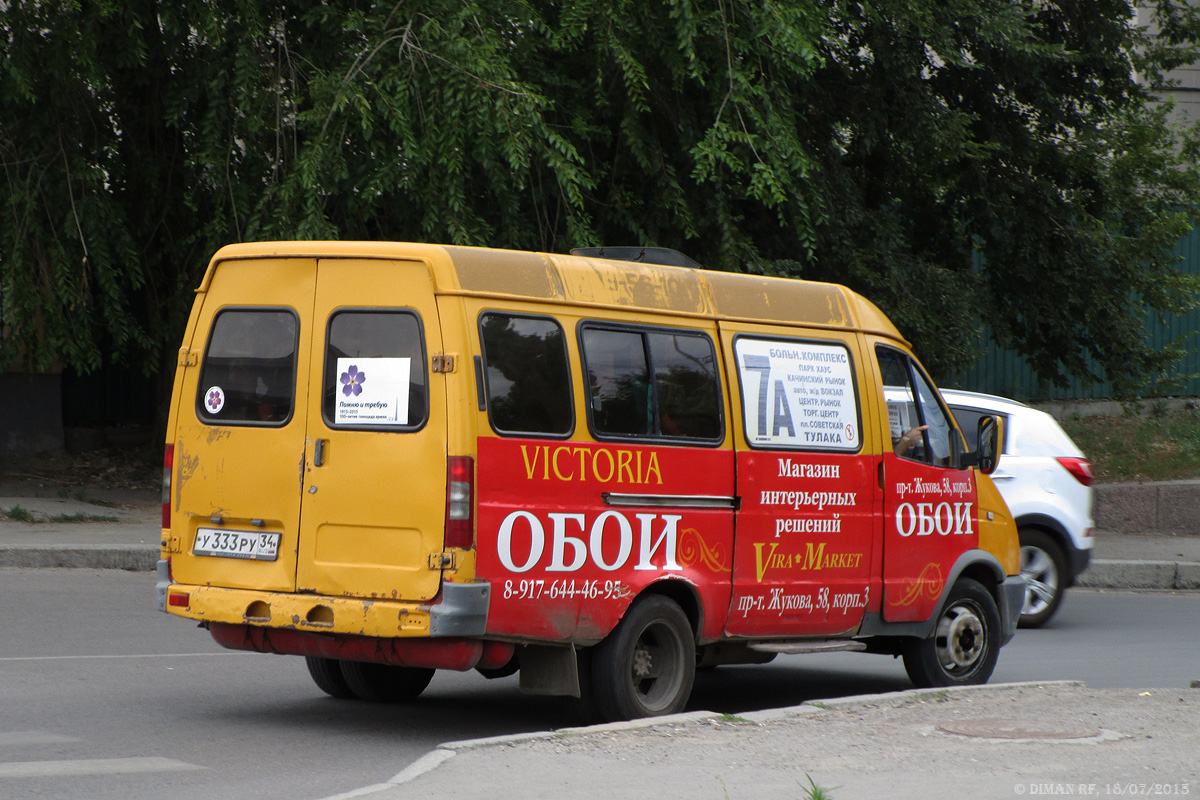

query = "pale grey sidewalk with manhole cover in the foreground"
[{"left": 364, "top": 682, "right": 1200, "bottom": 800}]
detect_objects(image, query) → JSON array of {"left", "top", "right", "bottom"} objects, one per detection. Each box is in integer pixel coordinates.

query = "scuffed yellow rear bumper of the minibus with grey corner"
[{"left": 157, "top": 561, "right": 491, "bottom": 638}]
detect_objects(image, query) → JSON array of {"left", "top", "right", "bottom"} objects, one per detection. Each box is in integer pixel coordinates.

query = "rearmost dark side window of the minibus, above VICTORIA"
[{"left": 480, "top": 313, "right": 574, "bottom": 435}]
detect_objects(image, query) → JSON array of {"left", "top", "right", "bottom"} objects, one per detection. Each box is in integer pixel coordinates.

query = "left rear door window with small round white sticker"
[{"left": 196, "top": 308, "right": 299, "bottom": 426}]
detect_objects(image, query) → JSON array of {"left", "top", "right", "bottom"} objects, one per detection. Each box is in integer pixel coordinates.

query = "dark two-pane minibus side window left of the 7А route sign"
[{"left": 581, "top": 325, "right": 725, "bottom": 443}]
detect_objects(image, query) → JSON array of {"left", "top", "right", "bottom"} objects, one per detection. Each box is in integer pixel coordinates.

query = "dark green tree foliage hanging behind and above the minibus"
[{"left": 0, "top": 0, "right": 1200, "bottom": 393}]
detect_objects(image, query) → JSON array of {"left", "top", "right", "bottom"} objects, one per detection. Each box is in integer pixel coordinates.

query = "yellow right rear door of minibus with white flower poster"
[{"left": 296, "top": 259, "right": 446, "bottom": 601}]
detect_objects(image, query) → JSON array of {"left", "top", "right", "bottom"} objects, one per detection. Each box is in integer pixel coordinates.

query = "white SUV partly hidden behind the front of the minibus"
[{"left": 942, "top": 390, "right": 1096, "bottom": 627}]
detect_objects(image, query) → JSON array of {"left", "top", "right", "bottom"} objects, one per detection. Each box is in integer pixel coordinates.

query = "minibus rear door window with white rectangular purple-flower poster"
[{"left": 322, "top": 309, "right": 430, "bottom": 431}]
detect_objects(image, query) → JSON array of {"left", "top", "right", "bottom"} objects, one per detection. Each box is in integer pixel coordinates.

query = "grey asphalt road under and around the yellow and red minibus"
[{"left": 0, "top": 570, "right": 1200, "bottom": 800}]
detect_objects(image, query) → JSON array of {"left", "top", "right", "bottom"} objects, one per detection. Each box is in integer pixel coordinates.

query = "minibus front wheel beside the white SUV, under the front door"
[{"left": 904, "top": 578, "right": 1000, "bottom": 688}]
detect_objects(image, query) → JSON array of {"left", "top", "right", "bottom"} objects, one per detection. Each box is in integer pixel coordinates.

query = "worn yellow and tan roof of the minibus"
[{"left": 197, "top": 241, "right": 905, "bottom": 342}]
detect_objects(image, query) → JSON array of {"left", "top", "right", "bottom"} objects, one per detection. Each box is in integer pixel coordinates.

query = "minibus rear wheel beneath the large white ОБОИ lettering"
[{"left": 592, "top": 595, "right": 696, "bottom": 722}]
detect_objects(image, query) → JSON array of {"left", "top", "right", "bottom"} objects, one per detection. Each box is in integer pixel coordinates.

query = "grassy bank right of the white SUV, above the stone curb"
[{"left": 1062, "top": 407, "right": 1200, "bottom": 483}]
